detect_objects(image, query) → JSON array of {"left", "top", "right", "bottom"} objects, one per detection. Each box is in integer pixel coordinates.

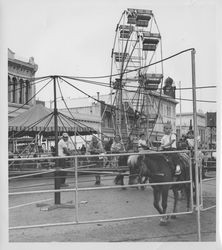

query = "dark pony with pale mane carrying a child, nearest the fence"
[{"left": 128, "top": 153, "right": 190, "bottom": 225}]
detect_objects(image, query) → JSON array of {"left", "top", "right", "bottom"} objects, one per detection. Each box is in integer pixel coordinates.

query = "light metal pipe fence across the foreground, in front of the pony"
[{"left": 9, "top": 150, "right": 215, "bottom": 238}]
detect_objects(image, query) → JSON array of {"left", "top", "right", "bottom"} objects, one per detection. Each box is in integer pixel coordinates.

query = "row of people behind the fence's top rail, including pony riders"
[{"left": 9, "top": 123, "right": 208, "bottom": 187}]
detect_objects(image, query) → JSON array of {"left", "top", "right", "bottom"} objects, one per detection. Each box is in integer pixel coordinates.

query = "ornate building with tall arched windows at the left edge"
[{"left": 8, "top": 49, "right": 38, "bottom": 119}]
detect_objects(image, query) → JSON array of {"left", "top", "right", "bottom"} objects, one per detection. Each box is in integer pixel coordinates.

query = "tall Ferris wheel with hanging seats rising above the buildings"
[{"left": 110, "top": 9, "right": 163, "bottom": 142}]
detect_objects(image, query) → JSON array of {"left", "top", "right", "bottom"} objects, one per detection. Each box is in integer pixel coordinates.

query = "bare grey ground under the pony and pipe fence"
[{"left": 9, "top": 173, "right": 216, "bottom": 242}]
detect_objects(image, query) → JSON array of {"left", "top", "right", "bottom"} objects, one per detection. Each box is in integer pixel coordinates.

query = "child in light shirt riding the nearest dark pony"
[{"left": 160, "top": 123, "right": 181, "bottom": 175}]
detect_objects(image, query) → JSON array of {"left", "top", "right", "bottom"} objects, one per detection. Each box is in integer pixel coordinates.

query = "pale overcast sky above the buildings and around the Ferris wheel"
[{"left": 1, "top": 0, "right": 219, "bottom": 112}]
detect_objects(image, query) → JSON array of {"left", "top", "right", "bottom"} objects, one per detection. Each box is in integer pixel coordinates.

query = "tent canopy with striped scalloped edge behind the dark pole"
[{"left": 8, "top": 104, "right": 97, "bottom": 137}]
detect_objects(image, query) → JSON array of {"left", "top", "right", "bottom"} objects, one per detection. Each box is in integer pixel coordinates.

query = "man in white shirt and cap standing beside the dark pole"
[{"left": 58, "top": 133, "right": 71, "bottom": 187}]
